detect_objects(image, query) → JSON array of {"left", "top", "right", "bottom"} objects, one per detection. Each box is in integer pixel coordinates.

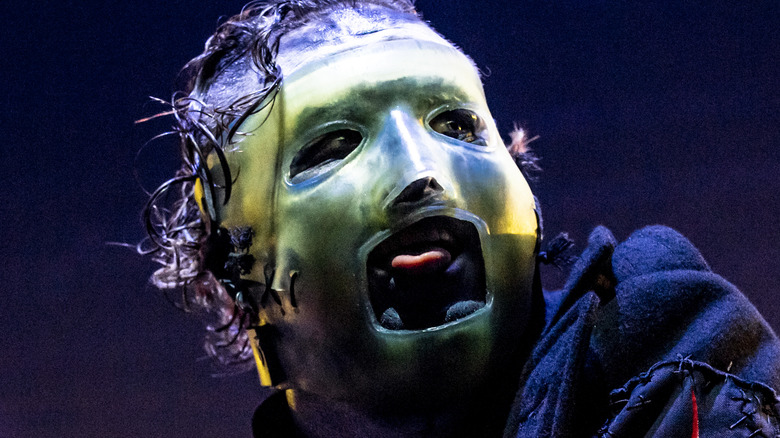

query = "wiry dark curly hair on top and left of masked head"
[{"left": 138, "top": 0, "right": 416, "bottom": 369}]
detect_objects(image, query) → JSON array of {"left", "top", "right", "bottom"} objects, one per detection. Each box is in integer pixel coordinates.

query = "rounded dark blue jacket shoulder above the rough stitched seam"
[{"left": 591, "top": 226, "right": 780, "bottom": 388}]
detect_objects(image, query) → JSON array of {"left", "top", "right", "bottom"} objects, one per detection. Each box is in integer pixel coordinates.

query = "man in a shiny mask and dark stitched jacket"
[{"left": 146, "top": 0, "right": 780, "bottom": 437}]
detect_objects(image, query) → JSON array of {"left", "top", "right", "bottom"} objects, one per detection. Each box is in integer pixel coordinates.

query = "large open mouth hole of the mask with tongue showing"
[{"left": 366, "top": 216, "right": 487, "bottom": 330}]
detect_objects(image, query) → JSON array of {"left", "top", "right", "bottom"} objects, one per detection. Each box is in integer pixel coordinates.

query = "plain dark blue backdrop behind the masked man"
[{"left": 0, "top": 0, "right": 780, "bottom": 437}]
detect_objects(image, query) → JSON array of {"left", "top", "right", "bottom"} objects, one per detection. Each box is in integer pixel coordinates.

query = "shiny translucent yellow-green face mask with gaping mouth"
[{"left": 206, "top": 30, "right": 538, "bottom": 408}]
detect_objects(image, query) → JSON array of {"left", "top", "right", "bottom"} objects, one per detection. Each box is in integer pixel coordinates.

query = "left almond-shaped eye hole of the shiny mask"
[{"left": 290, "top": 129, "right": 363, "bottom": 183}]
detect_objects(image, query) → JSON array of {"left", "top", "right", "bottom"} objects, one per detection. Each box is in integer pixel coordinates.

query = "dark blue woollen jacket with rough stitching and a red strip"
[{"left": 505, "top": 226, "right": 780, "bottom": 438}]
